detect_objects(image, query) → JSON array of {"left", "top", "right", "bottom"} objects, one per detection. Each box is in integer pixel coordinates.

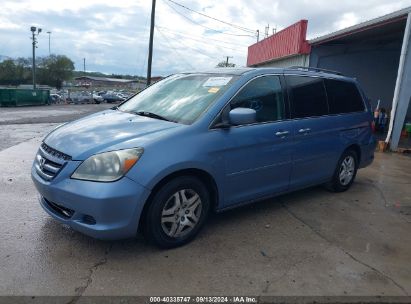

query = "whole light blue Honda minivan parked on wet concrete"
[{"left": 32, "top": 67, "right": 375, "bottom": 248}]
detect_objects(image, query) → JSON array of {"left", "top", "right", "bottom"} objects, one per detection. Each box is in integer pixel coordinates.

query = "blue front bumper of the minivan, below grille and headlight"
[{"left": 31, "top": 162, "right": 150, "bottom": 240}]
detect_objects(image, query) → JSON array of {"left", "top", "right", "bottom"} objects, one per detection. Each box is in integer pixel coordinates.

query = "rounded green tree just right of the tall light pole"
[{"left": 37, "top": 55, "right": 74, "bottom": 89}]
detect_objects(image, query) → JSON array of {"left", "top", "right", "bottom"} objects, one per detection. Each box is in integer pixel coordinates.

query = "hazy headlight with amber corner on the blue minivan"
[{"left": 71, "top": 148, "right": 143, "bottom": 182}]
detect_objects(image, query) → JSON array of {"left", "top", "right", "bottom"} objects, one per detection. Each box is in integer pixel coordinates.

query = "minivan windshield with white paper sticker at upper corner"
[{"left": 119, "top": 74, "right": 236, "bottom": 124}]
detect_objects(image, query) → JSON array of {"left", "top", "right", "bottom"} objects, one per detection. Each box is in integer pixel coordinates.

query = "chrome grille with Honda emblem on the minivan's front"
[{"left": 34, "top": 143, "right": 71, "bottom": 180}]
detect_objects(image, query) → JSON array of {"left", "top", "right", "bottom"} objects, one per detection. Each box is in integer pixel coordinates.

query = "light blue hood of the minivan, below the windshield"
[{"left": 44, "top": 110, "right": 181, "bottom": 160}]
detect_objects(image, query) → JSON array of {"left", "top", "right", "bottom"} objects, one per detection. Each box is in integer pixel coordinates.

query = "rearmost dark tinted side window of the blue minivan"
[{"left": 324, "top": 79, "right": 364, "bottom": 114}]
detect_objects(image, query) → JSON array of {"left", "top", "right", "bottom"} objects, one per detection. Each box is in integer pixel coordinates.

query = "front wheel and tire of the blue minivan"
[{"left": 143, "top": 176, "right": 210, "bottom": 248}]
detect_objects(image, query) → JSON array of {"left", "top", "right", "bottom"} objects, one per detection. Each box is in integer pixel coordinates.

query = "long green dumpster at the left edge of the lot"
[{"left": 0, "top": 89, "right": 50, "bottom": 107}]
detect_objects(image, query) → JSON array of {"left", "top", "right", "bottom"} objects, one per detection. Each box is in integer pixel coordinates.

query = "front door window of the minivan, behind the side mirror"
[{"left": 231, "top": 76, "right": 285, "bottom": 122}]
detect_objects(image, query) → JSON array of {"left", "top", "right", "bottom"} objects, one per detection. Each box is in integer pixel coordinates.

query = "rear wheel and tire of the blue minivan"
[{"left": 325, "top": 149, "right": 358, "bottom": 192}]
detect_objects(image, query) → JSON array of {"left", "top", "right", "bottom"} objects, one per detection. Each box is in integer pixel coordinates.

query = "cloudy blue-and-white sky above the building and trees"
[{"left": 0, "top": 0, "right": 411, "bottom": 76}]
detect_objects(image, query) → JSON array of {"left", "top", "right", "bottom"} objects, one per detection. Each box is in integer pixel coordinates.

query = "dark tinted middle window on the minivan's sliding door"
[{"left": 286, "top": 76, "right": 328, "bottom": 118}]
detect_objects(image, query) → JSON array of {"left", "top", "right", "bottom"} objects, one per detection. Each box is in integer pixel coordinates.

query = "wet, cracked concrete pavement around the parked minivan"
[{"left": 0, "top": 104, "right": 411, "bottom": 303}]
